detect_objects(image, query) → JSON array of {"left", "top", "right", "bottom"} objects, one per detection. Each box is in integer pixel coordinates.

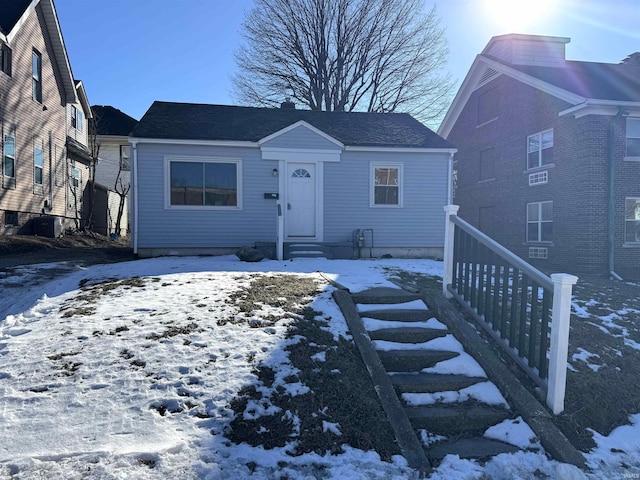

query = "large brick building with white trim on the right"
[{"left": 438, "top": 34, "right": 640, "bottom": 277}]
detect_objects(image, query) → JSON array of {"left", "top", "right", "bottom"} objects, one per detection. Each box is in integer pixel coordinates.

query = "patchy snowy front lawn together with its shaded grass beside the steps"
[{"left": 0, "top": 256, "right": 640, "bottom": 479}]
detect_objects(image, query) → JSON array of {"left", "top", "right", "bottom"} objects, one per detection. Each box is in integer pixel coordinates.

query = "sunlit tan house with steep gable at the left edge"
[{"left": 0, "top": 0, "right": 91, "bottom": 234}]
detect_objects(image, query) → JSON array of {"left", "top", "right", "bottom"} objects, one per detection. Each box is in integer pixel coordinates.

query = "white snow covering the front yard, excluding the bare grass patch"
[{"left": 0, "top": 256, "right": 640, "bottom": 480}]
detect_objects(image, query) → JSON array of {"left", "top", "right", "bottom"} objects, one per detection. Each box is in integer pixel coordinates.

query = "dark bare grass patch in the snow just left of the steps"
[{"left": 225, "top": 276, "right": 399, "bottom": 461}]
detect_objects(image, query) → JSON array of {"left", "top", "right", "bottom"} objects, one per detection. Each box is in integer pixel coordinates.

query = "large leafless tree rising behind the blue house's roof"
[{"left": 233, "top": 0, "right": 453, "bottom": 122}]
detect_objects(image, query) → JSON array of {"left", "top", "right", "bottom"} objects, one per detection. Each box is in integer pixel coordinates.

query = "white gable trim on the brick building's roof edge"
[{"left": 438, "top": 55, "right": 587, "bottom": 138}]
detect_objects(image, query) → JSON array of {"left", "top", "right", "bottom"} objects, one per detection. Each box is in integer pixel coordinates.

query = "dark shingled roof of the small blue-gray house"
[{"left": 131, "top": 102, "right": 454, "bottom": 148}]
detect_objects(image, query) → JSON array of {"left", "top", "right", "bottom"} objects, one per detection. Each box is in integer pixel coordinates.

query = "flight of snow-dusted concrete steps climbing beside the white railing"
[{"left": 334, "top": 288, "right": 532, "bottom": 468}]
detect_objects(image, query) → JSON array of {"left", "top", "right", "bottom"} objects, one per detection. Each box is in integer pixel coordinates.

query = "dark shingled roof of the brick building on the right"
[{"left": 498, "top": 60, "right": 640, "bottom": 102}]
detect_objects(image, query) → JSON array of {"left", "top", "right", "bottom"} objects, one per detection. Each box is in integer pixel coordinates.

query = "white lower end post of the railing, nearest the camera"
[{"left": 547, "top": 273, "right": 578, "bottom": 415}]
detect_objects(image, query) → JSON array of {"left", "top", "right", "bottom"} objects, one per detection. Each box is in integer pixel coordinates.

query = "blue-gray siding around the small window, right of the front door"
[{"left": 324, "top": 151, "right": 449, "bottom": 247}]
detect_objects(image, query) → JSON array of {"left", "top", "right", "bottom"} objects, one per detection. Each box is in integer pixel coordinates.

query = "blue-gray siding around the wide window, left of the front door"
[{"left": 137, "top": 143, "right": 278, "bottom": 248}]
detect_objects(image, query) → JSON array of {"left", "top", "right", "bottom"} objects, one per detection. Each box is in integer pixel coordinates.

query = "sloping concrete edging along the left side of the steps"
[{"left": 333, "top": 290, "right": 431, "bottom": 476}]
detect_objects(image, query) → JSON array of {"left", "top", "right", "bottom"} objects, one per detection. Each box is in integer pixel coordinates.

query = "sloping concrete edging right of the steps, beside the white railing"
[{"left": 423, "top": 294, "right": 586, "bottom": 469}]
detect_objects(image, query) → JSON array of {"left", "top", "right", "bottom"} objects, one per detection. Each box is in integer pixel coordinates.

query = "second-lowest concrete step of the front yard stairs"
[{"left": 405, "top": 404, "right": 512, "bottom": 436}]
